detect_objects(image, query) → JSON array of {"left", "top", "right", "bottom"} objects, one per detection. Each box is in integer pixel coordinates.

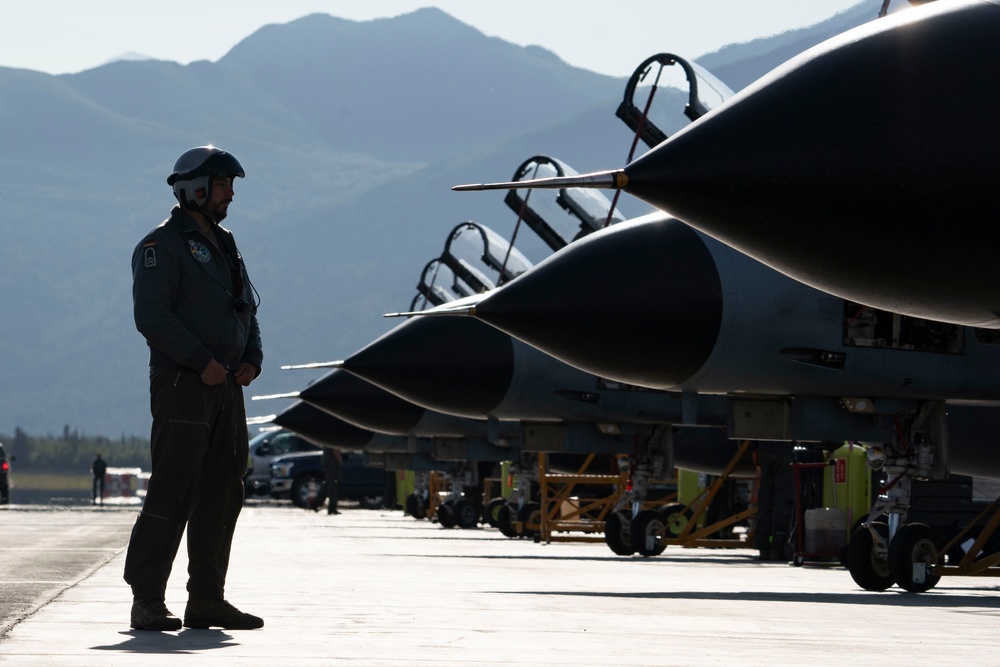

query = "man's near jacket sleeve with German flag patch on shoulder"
[{"left": 132, "top": 234, "right": 212, "bottom": 372}]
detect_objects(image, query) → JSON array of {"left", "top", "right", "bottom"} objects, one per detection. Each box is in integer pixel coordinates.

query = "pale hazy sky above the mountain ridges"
[{"left": 0, "top": 0, "right": 876, "bottom": 76}]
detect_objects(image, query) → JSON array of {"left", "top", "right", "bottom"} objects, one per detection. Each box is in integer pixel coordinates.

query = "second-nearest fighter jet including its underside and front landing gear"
[{"left": 431, "top": 206, "right": 1000, "bottom": 590}]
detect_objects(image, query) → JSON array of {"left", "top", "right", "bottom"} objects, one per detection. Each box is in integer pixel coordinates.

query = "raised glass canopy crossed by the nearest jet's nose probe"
[{"left": 504, "top": 155, "right": 625, "bottom": 252}]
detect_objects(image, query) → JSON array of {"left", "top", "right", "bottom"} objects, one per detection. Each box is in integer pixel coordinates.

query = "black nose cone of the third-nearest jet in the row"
[{"left": 343, "top": 317, "right": 514, "bottom": 419}]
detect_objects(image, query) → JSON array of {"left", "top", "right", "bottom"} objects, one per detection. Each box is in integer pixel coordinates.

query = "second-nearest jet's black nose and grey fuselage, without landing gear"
[{"left": 442, "top": 214, "right": 1000, "bottom": 401}]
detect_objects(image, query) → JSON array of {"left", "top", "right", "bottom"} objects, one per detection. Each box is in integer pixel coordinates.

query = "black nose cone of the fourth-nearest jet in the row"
[{"left": 299, "top": 368, "right": 426, "bottom": 435}]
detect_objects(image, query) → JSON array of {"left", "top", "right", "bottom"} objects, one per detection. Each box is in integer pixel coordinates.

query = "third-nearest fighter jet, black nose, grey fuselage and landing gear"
[{"left": 341, "top": 318, "right": 752, "bottom": 555}]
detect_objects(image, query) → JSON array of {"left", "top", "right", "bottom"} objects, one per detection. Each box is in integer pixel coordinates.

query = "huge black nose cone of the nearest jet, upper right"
[{"left": 625, "top": 0, "right": 1000, "bottom": 326}]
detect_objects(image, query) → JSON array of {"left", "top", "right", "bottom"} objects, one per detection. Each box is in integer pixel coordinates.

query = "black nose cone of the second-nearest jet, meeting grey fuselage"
[{"left": 476, "top": 215, "right": 722, "bottom": 389}]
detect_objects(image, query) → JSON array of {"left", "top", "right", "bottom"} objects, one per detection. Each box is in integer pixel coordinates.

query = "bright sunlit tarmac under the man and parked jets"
[{"left": 0, "top": 505, "right": 1000, "bottom": 667}]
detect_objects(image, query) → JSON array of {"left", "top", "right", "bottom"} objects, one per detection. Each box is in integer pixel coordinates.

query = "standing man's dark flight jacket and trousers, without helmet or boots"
[{"left": 125, "top": 206, "right": 263, "bottom": 600}]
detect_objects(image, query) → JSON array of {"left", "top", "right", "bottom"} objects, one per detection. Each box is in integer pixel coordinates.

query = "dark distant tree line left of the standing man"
[{"left": 0, "top": 425, "right": 150, "bottom": 472}]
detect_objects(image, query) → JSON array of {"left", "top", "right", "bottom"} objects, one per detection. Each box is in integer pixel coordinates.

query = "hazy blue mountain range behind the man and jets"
[{"left": 0, "top": 2, "right": 877, "bottom": 437}]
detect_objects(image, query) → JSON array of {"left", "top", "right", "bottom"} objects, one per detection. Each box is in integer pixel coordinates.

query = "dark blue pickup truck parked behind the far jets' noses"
[{"left": 271, "top": 451, "right": 386, "bottom": 509}]
